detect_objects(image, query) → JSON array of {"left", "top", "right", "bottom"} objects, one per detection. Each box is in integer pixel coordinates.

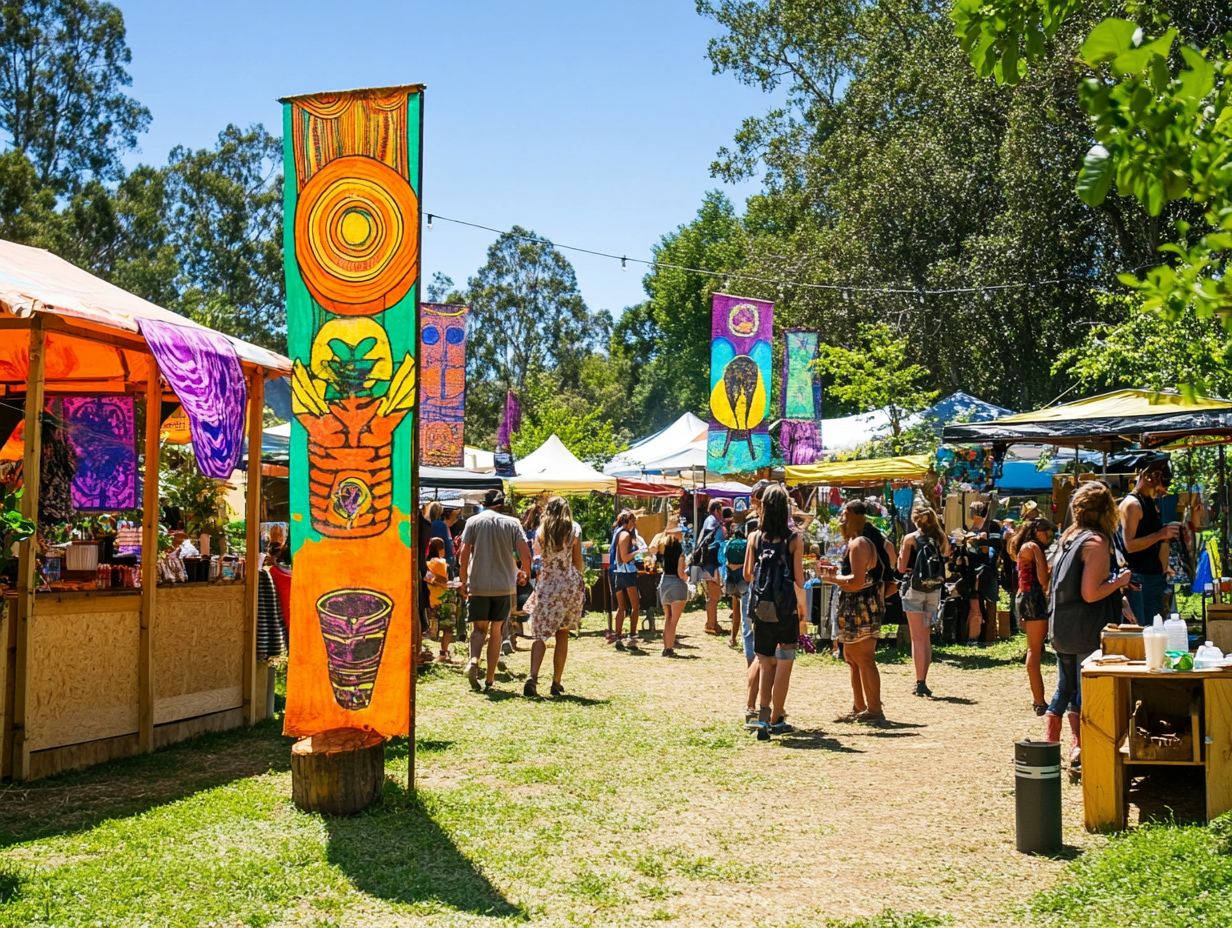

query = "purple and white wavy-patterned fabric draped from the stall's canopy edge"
[{"left": 140, "top": 319, "right": 248, "bottom": 479}]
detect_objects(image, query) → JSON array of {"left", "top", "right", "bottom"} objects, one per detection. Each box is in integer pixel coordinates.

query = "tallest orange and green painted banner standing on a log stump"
[{"left": 282, "top": 85, "right": 423, "bottom": 736}]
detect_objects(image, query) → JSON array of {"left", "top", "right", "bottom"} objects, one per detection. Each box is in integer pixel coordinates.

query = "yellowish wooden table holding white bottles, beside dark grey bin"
[{"left": 1082, "top": 661, "right": 1232, "bottom": 831}]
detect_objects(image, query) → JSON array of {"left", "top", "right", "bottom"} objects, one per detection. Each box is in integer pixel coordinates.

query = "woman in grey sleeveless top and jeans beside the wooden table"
[{"left": 1044, "top": 481, "right": 1132, "bottom": 769}]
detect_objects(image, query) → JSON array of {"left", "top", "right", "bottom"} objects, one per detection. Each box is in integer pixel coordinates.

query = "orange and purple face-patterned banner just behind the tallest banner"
[{"left": 419, "top": 303, "right": 471, "bottom": 467}]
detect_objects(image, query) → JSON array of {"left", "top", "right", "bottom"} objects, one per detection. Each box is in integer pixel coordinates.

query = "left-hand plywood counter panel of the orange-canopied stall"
[{"left": 26, "top": 595, "right": 140, "bottom": 751}]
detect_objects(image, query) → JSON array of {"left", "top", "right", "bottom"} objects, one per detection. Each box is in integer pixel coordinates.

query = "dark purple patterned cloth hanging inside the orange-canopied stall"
[{"left": 60, "top": 396, "right": 140, "bottom": 510}]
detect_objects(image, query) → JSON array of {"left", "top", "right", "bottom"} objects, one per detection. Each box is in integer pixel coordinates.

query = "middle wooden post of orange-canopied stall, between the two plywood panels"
[{"left": 137, "top": 355, "right": 163, "bottom": 754}]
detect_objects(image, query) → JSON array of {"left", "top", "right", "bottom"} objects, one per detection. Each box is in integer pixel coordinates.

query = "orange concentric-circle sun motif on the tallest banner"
[{"left": 296, "top": 155, "right": 419, "bottom": 315}]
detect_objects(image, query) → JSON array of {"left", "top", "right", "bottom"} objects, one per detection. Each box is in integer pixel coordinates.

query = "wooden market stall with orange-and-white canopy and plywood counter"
[{"left": 0, "top": 242, "right": 291, "bottom": 780}]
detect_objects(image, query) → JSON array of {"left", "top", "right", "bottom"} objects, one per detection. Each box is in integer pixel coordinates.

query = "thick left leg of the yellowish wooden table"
[{"left": 1082, "top": 674, "right": 1127, "bottom": 831}]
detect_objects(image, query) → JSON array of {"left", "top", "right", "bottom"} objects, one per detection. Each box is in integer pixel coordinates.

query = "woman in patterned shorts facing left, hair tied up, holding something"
[{"left": 822, "top": 499, "right": 887, "bottom": 722}]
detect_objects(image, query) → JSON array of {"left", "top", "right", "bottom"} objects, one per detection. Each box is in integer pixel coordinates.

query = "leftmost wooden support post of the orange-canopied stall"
[{"left": 10, "top": 322, "right": 47, "bottom": 780}]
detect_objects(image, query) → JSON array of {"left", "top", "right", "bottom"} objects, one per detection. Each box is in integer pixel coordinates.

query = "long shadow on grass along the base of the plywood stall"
[{"left": 0, "top": 718, "right": 294, "bottom": 847}]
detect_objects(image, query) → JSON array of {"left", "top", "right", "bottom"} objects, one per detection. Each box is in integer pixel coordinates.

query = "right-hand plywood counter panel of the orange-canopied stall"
[{"left": 150, "top": 583, "right": 244, "bottom": 725}]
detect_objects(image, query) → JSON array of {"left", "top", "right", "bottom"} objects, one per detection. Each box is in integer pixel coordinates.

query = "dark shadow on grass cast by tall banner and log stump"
[{"left": 323, "top": 780, "right": 527, "bottom": 921}]
